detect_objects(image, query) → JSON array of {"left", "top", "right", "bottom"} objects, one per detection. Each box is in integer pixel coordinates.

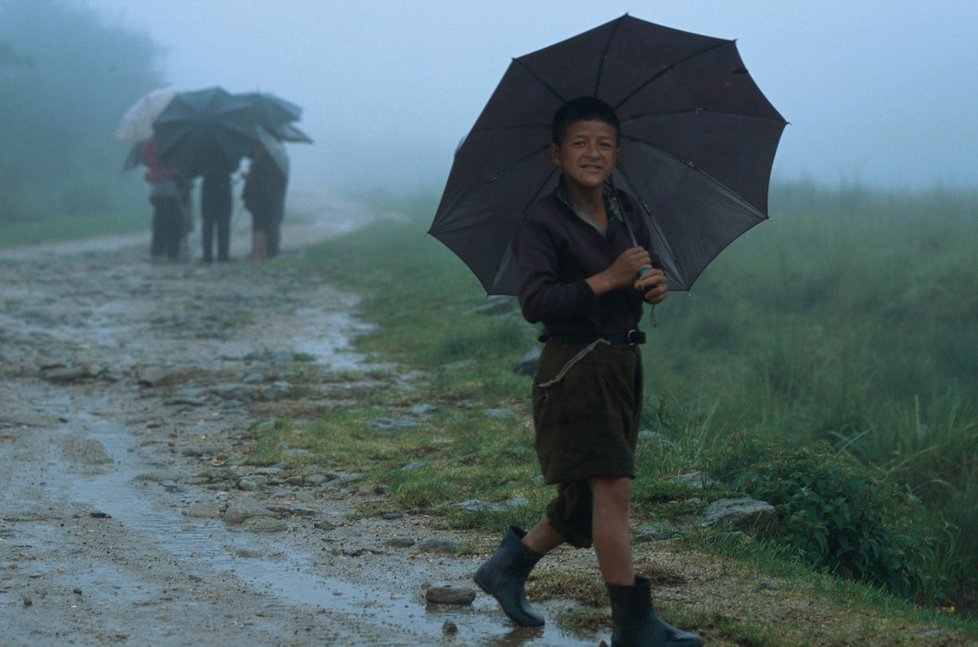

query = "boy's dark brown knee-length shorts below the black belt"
[{"left": 533, "top": 340, "right": 642, "bottom": 547}]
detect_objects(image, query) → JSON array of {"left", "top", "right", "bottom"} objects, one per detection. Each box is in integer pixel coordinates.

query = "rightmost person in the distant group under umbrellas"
[{"left": 241, "top": 144, "right": 288, "bottom": 263}]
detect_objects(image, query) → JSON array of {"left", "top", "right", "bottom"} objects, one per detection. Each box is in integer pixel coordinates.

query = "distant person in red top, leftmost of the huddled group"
[{"left": 140, "top": 140, "right": 189, "bottom": 260}]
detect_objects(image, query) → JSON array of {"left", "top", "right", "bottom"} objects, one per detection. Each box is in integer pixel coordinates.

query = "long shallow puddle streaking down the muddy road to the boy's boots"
[{"left": 62, "top": 414, "right": 598, "bottom": 647}]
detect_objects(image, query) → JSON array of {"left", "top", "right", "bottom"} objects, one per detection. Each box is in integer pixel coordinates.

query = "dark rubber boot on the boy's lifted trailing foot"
[{"left": 474, "top": 526, "right": 544, "bottom": 627}]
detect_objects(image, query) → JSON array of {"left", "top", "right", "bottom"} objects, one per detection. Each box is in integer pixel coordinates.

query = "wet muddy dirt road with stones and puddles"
[{"left": 0, "top": 202, "right": 597, "bottom": 647}]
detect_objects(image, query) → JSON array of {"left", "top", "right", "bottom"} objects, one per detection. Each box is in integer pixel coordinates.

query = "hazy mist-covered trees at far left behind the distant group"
[{"left": 0, "top": 0, "right": 158, "bottom": 225}]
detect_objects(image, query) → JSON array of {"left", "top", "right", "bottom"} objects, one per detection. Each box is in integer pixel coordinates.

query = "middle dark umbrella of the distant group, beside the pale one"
[{"left": 153, "top": 87, "right": 258, "bottom": 177}]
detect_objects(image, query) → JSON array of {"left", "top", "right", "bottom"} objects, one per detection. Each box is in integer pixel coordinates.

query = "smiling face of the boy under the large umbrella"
[{"left": 550, "top": 121, "right": 618, "bottom": 189}]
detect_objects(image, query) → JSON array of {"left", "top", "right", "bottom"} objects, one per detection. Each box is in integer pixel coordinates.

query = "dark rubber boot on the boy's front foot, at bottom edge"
[{"left": 607, "top": 577, "right": 703, "bottom": 647}]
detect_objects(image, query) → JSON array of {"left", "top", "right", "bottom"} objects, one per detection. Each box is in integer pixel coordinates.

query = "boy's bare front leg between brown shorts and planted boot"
[{"left": 590, "top": 477, "right": 635, "bottom": 586}]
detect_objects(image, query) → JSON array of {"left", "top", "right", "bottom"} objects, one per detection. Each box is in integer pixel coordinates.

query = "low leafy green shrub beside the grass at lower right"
[{"left": 715, "top": 440, "right": 949, "bottom": 603}]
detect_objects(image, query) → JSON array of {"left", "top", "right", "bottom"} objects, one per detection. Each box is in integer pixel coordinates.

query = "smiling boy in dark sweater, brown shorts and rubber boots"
[{"left": 475, "top": 97, "right": 703, "bottom": 647}]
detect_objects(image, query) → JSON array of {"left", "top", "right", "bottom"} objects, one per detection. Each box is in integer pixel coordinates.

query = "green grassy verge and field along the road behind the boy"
[{"left": 240, "top": 186, "right": 978, "bottom": 645}]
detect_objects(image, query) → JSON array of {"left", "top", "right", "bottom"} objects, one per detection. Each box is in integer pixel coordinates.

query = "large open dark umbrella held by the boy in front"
[{"left": 429, "top": 15, "right": 785, "bottom": 294}]
